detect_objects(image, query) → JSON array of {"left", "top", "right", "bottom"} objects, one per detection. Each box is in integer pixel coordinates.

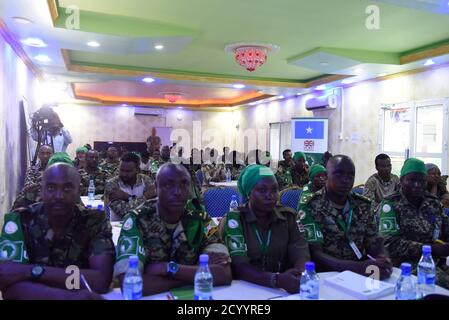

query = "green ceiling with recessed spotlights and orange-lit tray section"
[{"left": 0, "top": 0, "right": 449, "bottom": 108}]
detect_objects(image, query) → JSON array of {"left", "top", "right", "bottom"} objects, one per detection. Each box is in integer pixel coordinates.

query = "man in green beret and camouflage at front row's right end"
[{"left": 378, "top": 158, "right": 449, "bottom": 289}]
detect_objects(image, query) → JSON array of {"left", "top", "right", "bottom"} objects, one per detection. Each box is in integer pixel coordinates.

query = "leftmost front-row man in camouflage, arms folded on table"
[{"left": 0, "top": 163, "right": 115, "bottom": 300}]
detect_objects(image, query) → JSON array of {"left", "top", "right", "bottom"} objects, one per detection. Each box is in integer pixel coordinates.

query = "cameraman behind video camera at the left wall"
[{"left": 31, "top": 107, "right": 73, "bottom": 153}]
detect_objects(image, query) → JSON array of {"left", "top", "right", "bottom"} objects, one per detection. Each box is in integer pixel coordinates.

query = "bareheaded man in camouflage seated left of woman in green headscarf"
[{"left": 114, "top": 163, "right": 232, "bottom": 295}]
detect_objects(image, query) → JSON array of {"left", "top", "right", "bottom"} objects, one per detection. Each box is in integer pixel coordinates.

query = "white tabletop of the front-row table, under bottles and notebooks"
[{"left": 103, "top": 268, "right": 449, "bottom": 300}]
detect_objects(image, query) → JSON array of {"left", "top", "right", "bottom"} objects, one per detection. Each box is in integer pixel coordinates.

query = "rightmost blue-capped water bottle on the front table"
[{"left": 418, "top": 246, "right": 435, "bottom": 298}]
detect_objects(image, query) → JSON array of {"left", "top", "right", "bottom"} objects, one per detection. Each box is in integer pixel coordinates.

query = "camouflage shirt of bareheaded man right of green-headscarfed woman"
[{"left": 299, "top": 188, "right": 382, "bottom": 261}]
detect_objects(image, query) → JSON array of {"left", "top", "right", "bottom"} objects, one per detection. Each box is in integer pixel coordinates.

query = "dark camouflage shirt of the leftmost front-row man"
[{"left": 12, "top": 202, "right": 115, "bottom": 269}]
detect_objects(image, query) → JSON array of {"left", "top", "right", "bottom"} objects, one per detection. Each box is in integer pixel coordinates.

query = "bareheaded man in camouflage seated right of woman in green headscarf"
[{"left": 299, "top": 155, "right": 392, "bottom": 279}]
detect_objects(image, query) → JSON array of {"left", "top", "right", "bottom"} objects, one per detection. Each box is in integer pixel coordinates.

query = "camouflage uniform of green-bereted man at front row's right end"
[{"left": 378, "top": 191, "right": 449, "bottom": 289}]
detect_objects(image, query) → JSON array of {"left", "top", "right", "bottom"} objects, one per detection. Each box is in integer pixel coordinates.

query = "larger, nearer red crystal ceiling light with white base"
[{"left": 225, "top": 43, "right": 279, "bottom": 72}]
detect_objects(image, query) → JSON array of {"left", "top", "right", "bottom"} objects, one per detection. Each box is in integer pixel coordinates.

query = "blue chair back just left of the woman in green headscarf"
[{"left": 203, "top": 187, "right": 242, "bottom": 218}]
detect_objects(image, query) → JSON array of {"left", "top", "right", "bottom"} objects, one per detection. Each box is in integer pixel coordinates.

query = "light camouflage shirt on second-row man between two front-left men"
[{"left": 104, "top": 173, "right": 156, "bottom": 219}]
